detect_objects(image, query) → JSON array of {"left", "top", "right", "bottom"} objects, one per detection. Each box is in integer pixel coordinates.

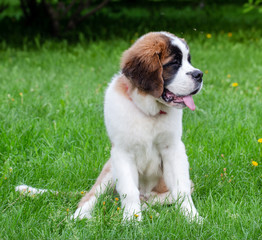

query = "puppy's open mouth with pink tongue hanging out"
[{"left": 162, "top": 88, "right": 199, "bottom": 111}]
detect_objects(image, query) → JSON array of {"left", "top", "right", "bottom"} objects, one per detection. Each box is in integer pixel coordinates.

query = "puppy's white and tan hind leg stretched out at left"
[{"left": 72, "top": 159, "right": 113, "bottom": 219}]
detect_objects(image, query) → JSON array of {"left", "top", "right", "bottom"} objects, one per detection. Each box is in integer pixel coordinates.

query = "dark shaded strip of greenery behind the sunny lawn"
[{"left": 0, "top": 0, "right": 262, "bottom": 46}]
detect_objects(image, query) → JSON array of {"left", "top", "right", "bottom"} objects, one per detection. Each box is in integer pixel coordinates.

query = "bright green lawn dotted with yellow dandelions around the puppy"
[{"left": 0, "top": 3, "right": 262, "bottom": 239}]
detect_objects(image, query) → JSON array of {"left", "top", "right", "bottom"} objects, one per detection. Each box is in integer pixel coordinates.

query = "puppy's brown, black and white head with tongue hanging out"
[{"left": 121, "top": 32, "right": 203, "bottom": 110}]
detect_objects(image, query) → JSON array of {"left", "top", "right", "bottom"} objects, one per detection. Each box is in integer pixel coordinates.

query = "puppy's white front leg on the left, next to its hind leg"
[{"left": 111, "top": 147, "right": 141, "bottom": 220}]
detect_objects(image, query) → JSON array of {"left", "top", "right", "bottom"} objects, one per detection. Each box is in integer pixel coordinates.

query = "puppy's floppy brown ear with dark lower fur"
[{"left": 121, "top": 34, "right": 166, "bottom": 98}]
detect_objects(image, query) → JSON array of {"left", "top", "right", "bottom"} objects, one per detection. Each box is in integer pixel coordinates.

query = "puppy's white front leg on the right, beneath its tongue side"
[{"left": 162, "top": 141, "right": 200, "bottom": 220}]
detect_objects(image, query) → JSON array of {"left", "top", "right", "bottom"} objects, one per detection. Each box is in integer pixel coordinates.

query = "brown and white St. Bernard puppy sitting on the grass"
[{"left": 73, "top": 32, "right": 203, "bottom": 220}]
